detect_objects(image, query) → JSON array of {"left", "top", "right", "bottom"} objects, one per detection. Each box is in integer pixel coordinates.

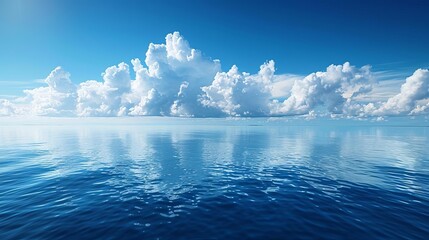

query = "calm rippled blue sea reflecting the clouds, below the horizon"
[{"left": 0, "top": 118, "right": 429, "bottom": 239}]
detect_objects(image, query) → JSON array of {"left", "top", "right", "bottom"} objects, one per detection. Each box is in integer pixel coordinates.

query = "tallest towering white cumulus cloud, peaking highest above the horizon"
[{"left": 128, "top": 32, "right": 221, "bottom": 116}]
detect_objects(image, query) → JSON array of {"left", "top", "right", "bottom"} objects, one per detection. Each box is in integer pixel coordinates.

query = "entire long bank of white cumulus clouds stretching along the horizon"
[{"left": 0, "top": 32, "right": 429, "bottom": 117}]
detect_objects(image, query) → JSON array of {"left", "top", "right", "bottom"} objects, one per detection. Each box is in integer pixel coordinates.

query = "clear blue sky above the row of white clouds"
[{"left": 0, "top": 0, "right": 429, "bottom": 118}]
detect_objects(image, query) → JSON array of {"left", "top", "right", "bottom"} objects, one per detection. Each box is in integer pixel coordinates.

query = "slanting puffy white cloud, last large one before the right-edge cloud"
[{"left": 272, "top": 62, "right": 374, "bottom": 115}]
